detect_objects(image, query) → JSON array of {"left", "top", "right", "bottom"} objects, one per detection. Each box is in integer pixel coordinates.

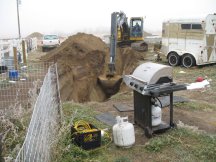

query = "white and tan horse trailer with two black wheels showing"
[{"left": 161, "top": 14, "right": 216, "bottom": 68}]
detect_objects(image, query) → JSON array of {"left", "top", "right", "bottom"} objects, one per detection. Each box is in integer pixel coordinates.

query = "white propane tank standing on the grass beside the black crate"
[{"left": 113, "top": 116, "right": 135, "bottom": 148}]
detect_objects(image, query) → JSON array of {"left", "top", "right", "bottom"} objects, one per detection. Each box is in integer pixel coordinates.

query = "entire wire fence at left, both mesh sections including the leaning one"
[{"left": 0, "top": 63, "right": 61, "bottom": 162}]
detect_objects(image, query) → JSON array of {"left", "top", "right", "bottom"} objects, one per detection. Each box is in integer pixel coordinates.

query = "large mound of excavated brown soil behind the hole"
[{"left": 41, "top": 33, "right": 141, "bottom": 102}]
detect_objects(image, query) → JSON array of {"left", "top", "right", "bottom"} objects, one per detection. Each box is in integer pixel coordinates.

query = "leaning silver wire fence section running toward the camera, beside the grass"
[{"left": 15, "top": 66, "right": 60, "bottom": 162}]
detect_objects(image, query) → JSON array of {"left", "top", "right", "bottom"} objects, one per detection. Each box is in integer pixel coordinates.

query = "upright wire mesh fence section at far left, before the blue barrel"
[{"left": 0, "top": 63, "right": 53, "bottom": 110}]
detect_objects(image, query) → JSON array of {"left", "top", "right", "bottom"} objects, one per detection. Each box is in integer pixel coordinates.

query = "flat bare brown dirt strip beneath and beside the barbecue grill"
[{"left": 89, "top": 93, "right": 216, "bottom": 146}]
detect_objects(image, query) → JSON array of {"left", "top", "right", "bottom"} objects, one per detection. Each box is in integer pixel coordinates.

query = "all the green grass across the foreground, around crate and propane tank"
[{"left": 53, "top": 103, "right": 216, "bottom": 162}]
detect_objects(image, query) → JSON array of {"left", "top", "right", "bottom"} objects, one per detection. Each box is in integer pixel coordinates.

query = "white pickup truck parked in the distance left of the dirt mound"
[{"left": 42, "top": 35, "right": 60, "bottom": 52}]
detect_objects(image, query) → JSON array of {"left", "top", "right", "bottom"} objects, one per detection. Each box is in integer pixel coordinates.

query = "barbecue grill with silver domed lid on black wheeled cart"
[{"left": 123, "top": 62, "right": 187, "bottom": 137}]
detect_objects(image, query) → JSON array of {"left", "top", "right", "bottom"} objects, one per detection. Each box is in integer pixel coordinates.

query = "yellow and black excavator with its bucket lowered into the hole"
[{"left": 98, "top": 12, "right": 148, "bottom": 96}]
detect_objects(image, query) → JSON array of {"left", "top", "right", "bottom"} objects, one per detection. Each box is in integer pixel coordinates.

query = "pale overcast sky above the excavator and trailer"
[{"left": 0, "top": 0, "right": 216, "bottom": 38}]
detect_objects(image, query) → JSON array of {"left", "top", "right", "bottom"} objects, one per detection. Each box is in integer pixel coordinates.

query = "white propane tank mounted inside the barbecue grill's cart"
[{"left": 151, "top": 105, "right": 162, "bottom": 127}]
